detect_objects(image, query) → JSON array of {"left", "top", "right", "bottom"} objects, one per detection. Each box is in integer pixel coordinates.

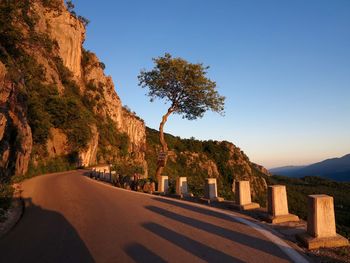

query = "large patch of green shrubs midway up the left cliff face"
[{"left": 14, "top": 54, "right": 94, "bottom": 150}]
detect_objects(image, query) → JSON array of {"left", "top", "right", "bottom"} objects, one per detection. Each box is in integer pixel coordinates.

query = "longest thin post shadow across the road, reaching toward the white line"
[{"left": 146, "top": 206, "right": 289, "bottom": 260}]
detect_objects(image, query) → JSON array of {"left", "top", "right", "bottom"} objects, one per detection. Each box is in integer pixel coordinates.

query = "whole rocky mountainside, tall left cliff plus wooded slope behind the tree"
[{"left": 0, "top": 0, "right": 269, "bottom": 203}]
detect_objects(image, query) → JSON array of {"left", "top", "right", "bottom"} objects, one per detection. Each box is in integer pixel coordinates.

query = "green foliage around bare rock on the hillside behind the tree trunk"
[{"left": 146, "top": 128, "right": 241, "bottom": 200}]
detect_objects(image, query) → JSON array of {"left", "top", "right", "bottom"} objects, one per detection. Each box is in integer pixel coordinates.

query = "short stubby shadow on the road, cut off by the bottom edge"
[{"left": 124, "top": 243, "right": 166, "bottom": 263}]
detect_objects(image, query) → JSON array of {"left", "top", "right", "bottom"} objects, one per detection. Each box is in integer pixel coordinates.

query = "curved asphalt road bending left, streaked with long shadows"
[{"left": 0, "top": 171, "right": 308, "bottom": 263}]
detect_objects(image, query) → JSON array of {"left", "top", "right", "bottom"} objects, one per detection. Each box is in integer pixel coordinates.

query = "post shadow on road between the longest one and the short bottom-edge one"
[{"left": 142, "top": 223, "right": 244, "bottom": 263}]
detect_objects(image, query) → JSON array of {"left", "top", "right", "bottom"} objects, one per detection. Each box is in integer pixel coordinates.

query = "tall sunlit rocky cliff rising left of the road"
[{"left": 0, "top": 0, "right": 147, "bottom": 178}]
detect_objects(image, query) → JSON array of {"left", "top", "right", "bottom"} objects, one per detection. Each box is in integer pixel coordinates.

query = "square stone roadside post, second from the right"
[{"left": 267, "top": 185, "right": 299, "bottom": 224}]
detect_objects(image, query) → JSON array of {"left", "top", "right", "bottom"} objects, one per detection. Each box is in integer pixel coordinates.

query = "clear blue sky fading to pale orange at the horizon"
[{"left": 73, "top": 0, "right": 350, "bottom": 168}]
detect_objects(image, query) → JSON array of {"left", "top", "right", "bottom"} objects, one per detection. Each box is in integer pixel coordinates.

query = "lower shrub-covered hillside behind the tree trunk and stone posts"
[{"left": 146, "top": 128, "right": 269, "bottom": 206}]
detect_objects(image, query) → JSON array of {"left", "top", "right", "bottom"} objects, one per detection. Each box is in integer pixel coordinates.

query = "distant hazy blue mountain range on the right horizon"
[{"left": 269, "top": 154, "right": 350, "bottom": 182}]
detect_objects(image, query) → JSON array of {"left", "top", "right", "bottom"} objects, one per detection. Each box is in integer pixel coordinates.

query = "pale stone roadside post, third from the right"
[{"left": 235, "top": 181, "right": 260, "bottom": 210}]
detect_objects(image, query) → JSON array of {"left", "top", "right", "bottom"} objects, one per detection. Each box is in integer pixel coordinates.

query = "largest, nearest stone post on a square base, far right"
[{"left": 297, "top": 194, "right": 349, "bottom": 249}]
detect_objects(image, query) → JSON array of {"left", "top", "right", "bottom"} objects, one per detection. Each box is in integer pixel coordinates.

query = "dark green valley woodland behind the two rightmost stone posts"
[{"left": 268, "top": 176, "right": 350, "bottom": 238}]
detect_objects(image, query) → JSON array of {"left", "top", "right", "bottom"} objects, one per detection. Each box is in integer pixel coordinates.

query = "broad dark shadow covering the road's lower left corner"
[{"left": 0, "top": 198, "right": 94, "bottom": 263}]
